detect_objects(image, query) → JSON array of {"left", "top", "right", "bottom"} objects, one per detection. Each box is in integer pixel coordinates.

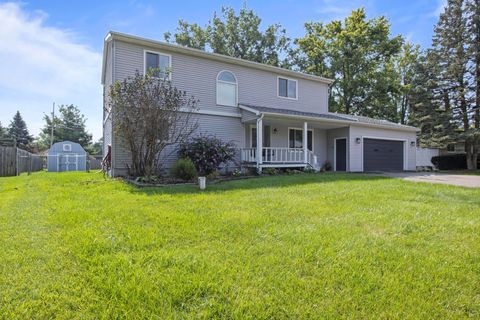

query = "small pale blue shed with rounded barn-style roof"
[{"left": 47, "top": 141, "right": 87, "bottom": 172}]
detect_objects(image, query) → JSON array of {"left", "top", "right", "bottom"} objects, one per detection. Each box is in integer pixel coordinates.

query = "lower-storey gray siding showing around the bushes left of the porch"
[{"left": 109, "top": 114, "right": 245, "bottom": 176}]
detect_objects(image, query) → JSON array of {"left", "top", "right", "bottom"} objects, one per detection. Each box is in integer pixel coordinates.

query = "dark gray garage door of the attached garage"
[{"left": 363, "top": 139, "right": 404, "bottom": 171}]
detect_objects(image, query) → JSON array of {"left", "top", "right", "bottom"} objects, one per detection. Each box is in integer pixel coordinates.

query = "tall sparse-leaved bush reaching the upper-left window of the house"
[{"left": 110, "top": 72, "right": 198, "bottom": 176}]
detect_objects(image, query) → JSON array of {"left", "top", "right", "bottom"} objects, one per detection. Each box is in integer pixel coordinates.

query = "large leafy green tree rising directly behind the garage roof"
[{"left": 294, "top": 8, "right": 403, "bottom": 120}]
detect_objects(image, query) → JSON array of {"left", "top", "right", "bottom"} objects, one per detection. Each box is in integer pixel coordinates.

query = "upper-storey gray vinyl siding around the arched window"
[{"left": 115, "top": 40, "right": 328, "bottom": 114}]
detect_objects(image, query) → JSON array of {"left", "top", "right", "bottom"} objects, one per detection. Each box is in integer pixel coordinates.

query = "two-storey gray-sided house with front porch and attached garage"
[{"left": 102, "top": 32, "right": 418, "bottom": 176}]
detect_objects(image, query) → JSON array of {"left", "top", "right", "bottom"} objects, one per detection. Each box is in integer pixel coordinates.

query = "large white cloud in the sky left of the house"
[{"left": 0, "top": 3, "right": 102, "bottom": 139}]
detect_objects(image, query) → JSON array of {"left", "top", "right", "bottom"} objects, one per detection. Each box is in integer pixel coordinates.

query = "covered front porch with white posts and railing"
[{"left": 240, "top": 104, "right": 349, "bottom": 172}]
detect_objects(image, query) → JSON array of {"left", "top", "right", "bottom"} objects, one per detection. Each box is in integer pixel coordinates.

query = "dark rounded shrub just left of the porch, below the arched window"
[{"left": 178, "top": 136, "right": 236, "bottom": 176}]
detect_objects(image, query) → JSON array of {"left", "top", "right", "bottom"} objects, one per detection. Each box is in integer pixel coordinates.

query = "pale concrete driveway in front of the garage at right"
[{"left": 383, "top": 172, "right": 480, "bottom": 188}]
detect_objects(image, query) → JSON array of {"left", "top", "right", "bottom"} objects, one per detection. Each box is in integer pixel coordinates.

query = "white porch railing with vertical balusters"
[{"left": 241, "top": 147, "right": 317, "bottom": 167}]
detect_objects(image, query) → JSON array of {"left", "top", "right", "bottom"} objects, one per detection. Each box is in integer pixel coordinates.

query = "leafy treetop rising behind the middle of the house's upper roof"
[{"left": 164, "top": 6, "right": 289, "bottom": 66}]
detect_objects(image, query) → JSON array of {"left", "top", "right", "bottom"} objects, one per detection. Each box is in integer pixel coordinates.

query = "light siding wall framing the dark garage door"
[{"left": 349, "top": 126, "right": 417, "bottom": 172}]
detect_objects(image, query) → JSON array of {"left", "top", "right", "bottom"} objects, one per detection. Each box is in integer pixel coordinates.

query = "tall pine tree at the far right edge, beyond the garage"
[{"left": 432, "top": 0, "right": 480, "bottom": 169}]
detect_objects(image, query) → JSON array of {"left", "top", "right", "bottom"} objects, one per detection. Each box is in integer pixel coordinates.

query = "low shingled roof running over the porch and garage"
[{"left": 239, "top": 103, "right": 420, "bottom": 131}]
